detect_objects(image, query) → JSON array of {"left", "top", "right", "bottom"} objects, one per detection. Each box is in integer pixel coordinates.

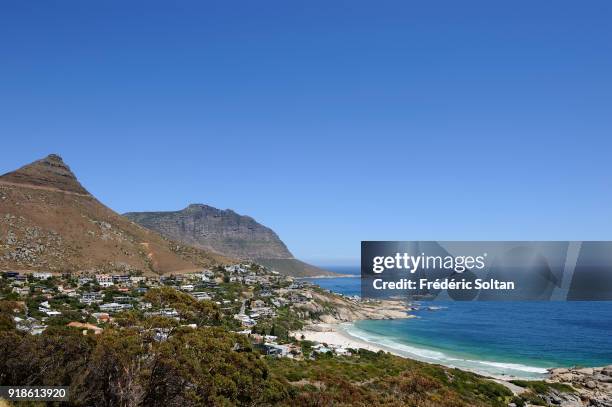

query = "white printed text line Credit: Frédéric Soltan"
[{"left": 372, "top": 278, "right": 515, "bottom": 290}]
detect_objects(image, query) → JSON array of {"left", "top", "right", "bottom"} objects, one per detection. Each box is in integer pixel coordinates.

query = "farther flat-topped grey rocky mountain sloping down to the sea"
[{"left": 124, "top": 204, "right": 334, "bottom": 276}]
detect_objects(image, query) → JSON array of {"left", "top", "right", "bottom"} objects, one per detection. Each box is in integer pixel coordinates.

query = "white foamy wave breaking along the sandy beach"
[{"left": 342, "top": 324, "right": 548, "bottom": 379}]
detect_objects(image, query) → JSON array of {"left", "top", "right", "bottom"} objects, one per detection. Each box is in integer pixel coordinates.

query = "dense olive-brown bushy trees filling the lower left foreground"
[{"left": 0, "top": 328, "right": 276, "bottom": 406}]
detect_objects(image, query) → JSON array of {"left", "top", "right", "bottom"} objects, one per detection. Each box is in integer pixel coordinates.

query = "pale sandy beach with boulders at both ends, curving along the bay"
[{"left": 292, "top": 275, "right": 612, "bottom": 406}]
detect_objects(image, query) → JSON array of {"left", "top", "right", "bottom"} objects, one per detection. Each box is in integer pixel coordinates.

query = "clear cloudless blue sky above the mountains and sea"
[{"left": 0, "top": 0, "right": 612, "bottom": 264}]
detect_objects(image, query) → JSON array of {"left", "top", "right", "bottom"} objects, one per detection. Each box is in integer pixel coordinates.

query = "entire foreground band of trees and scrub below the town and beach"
[{"left": 0, "top": 328, "right": 511, "bottom": 406}]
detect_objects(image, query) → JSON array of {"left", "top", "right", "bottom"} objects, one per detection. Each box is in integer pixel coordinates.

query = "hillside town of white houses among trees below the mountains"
[{"left": 0, "top": 263, "right": 382, "bottom": 359}]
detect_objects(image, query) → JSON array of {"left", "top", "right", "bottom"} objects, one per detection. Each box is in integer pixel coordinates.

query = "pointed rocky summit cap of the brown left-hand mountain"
[{"left": 0, "top": 154, "right": 89, "bottom": 195}]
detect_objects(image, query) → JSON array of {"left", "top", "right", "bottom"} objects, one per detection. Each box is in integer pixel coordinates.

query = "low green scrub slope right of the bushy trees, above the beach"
[{"left": 268, "top": 349, "right": 512, "bottom": 406}]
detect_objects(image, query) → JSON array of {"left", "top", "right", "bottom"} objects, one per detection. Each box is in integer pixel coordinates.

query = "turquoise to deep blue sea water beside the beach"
[{"left": 310, "top": 267, "right": 612, "bottom": 378}]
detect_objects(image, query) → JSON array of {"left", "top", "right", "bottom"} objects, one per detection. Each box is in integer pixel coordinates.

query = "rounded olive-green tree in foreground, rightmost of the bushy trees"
[{"left": 144, "top": 328, "right": 269, "bottom": 406}]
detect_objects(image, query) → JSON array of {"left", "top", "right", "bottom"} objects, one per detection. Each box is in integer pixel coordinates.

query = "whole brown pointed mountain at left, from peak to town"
[{"left": 0, "top": 154, "right": 229, "bottom": 274}]
